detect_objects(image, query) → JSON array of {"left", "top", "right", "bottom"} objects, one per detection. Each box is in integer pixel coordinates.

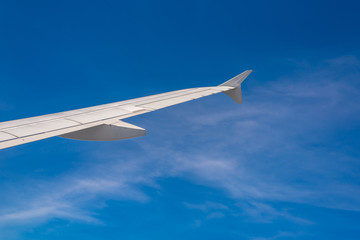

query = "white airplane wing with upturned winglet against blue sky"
[{"left": 0, "top": 70, "right": 252, "bottom": 149}]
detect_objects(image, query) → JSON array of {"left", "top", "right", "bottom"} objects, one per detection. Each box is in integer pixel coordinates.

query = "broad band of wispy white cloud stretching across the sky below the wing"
[{"left": 0, "top": 56, "right": 360, "bottom": 231}]
